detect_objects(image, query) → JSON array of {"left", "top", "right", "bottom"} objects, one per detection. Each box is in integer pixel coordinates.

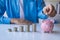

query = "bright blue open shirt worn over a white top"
[{"left": 0, "top": 0, "right": 48, "bottom": 24}]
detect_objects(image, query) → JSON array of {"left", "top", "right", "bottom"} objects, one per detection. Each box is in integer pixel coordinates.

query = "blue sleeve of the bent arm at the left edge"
[{"left": 0, "top": 0, "right": 10, "bottom": 24}]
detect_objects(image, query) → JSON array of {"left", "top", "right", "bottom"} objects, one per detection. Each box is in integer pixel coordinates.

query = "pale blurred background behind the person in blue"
[{"left": 4, "top": 0, "right": 60, "bottom": 23}]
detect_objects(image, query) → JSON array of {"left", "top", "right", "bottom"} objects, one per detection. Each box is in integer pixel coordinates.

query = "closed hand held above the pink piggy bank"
[{"left": 43, "top": 4, "right": 56, "bottom": 17}]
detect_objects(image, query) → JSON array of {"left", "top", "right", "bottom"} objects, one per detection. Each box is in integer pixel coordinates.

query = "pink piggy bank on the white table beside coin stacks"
[{"left": 41, "top": 20, "right": 54, "bottom": 33}]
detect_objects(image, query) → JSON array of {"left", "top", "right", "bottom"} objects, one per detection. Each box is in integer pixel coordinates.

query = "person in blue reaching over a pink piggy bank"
[{"left": 0, "top": 0, "right": 55, "bottom": 24}]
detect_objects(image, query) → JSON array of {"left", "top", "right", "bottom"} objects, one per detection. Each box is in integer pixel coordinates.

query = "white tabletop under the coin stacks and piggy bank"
[{"left": 0, "top": 24, "right": 60, "bottom": 40}]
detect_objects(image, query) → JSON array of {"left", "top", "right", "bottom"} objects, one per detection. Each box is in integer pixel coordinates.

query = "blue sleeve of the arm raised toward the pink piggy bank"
[{"left": 38, "top": 0, "right": 48, "bottom": 19}]
